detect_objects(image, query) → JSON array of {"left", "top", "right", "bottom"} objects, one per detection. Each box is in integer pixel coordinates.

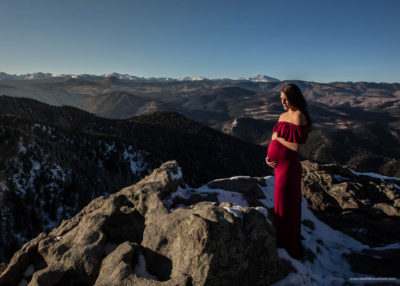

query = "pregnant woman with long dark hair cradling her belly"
[{"left": 266, "top": 84, "right": 311, "bottom": 259}]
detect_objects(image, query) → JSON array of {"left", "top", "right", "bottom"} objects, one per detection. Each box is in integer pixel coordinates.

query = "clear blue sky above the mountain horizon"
[{"left": 0, "top": 0, "right": 400, "bottom": 82}]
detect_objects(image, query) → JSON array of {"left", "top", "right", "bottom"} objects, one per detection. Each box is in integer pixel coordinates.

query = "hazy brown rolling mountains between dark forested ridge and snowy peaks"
[{"left": 0, "top": 73, "right": 400, "bottom": 177}]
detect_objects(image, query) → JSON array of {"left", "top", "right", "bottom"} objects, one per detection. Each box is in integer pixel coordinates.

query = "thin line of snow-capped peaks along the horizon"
[{"left": 0, "top": 72, "right": 280, "bottom": 82}]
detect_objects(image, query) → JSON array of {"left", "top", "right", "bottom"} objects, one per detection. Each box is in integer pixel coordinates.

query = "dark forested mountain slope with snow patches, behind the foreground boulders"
[{"left": 0, "top": 96, "right": 269, "bottom": 260}]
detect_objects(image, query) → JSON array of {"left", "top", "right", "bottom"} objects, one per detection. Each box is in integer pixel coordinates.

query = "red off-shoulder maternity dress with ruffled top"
[{"left": 268, "top": 121, "right": 309, "bottom": 259}]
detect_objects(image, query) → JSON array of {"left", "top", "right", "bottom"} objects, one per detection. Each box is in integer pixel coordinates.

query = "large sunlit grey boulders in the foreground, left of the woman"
[{"left": 0, "top": 161, "right": 293, "bottom": 286}]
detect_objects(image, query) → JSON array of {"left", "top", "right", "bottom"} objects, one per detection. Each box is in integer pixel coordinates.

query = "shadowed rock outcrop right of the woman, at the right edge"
[{"left": 302, "top": 161, "right": 400, "bottom": 246}]
